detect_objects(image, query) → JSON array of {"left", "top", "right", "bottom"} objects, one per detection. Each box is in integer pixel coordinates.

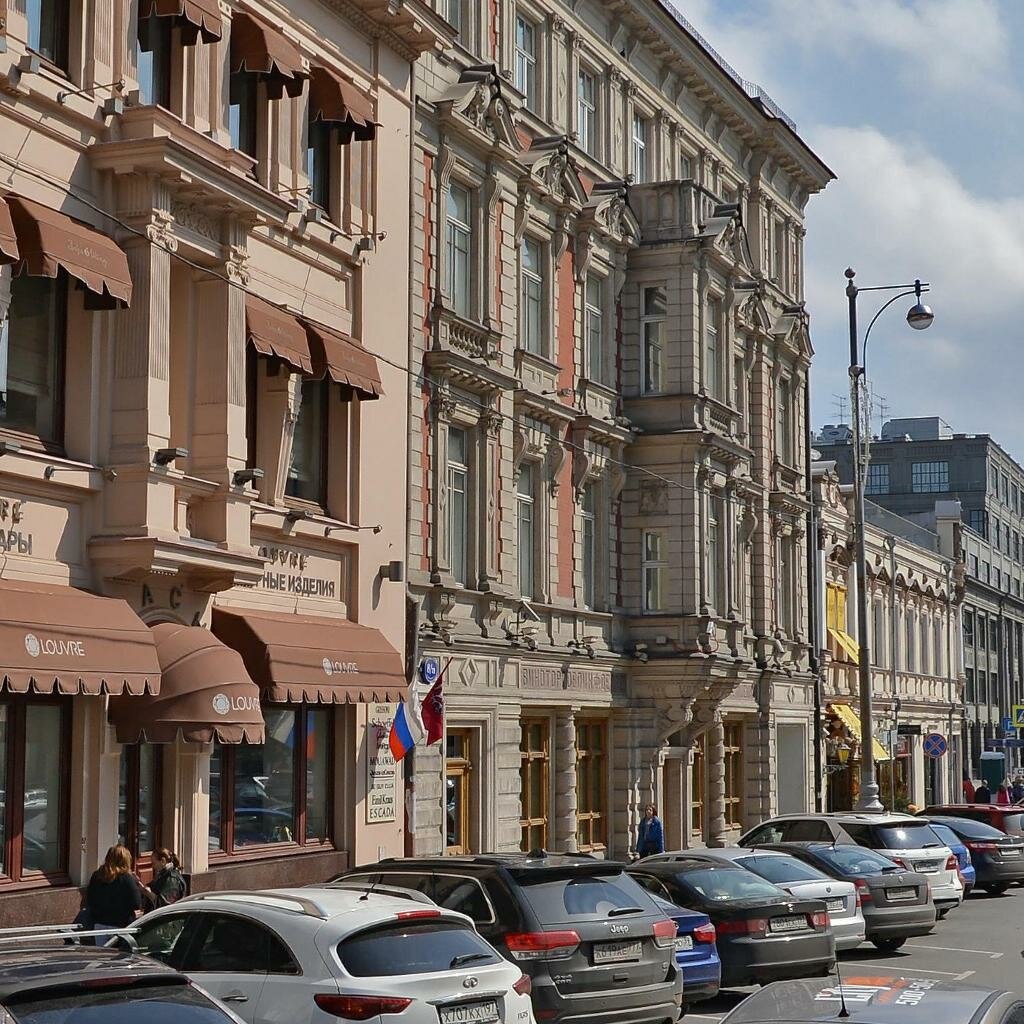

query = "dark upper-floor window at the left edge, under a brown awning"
[{"left": 0, "top": 267, "right": 68, "bottom": 445}]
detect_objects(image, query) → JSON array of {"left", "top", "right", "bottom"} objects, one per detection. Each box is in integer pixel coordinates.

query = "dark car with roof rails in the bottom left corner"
[{"left": 0, "top": 938, "right": 243, "bottom": 1024}]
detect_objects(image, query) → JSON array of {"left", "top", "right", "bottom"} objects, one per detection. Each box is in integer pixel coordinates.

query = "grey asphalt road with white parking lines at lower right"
[{"left": 685, "top": 888, "right": 1024, "bottom": 1024}]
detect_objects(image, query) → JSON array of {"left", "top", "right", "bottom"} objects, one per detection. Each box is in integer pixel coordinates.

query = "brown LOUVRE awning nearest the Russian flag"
[{"left": 213, "top": 607, "right": 407, "bottom": 703}]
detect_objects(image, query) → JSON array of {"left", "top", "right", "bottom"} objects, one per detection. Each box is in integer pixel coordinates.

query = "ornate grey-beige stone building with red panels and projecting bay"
[{"left": 409, "top": 0, "right": 831, "bottom": 856}]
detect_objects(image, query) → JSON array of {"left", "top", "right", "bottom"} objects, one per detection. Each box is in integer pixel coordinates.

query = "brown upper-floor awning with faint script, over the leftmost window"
[{"left": 6, "top": 196, "right": 131, "bottom": 306}]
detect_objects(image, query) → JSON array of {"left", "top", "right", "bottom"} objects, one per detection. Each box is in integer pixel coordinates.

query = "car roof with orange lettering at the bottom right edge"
[{"left": 725, "top": 971, "right": 1016, "bottom": 1024}]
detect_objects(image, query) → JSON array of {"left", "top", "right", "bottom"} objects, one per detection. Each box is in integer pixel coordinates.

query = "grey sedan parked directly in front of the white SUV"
[{"left": 756, "top": 843, "right": 935, "bottom": 952}]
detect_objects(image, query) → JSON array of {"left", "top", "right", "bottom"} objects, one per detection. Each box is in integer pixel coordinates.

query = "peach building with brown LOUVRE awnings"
[{"left": 0, "top": 0, "right": 451, "bottom": 924}]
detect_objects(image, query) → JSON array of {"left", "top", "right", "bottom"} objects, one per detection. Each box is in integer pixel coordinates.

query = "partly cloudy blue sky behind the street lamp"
[{"left": 673, "top": 0, "right": 1024, "bottom": 463}]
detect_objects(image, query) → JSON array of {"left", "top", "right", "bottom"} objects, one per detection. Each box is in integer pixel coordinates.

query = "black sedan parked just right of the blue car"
[{"left": 630, "top": 853, "right": 836, "bottom": 988}]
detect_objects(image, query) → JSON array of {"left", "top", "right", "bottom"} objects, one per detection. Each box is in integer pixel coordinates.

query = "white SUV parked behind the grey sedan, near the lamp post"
[{"left": 738, "top": 812, "right": 964, "bottom": 918}]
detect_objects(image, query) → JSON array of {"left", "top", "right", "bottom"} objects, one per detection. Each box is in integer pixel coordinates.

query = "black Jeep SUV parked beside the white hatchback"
[{"left": 332, "top": 852, "right": 683, "bottom": 1024}]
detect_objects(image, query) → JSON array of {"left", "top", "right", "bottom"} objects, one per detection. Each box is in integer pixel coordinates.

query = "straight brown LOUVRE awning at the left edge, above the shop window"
[{"left": 0, "top": 580, "right": 160, "bottom": 700}]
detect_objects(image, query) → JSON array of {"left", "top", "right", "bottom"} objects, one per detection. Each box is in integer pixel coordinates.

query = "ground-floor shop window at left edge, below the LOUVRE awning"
[{"left": 0, "top": 697, "right": 71, "bottom": 882}]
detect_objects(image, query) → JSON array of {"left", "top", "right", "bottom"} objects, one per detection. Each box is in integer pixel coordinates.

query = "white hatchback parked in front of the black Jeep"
[{"left": 128, "top": 886, "right": 535, "bottom": 1024}]
